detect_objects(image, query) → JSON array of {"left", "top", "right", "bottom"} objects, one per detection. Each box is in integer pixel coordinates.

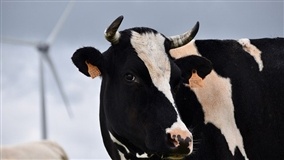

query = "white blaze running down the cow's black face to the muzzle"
[{"left": 131, "top": 31, "right": 188, "bottom": 143}]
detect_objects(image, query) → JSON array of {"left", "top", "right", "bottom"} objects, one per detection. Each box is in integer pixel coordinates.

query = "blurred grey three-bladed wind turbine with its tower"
[{"left": 2, "top": 1, "right": 74, "bottom": 139}]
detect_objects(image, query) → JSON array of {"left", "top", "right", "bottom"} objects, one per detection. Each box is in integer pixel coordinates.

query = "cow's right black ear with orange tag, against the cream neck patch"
[{"left": 175, "top": 55, "right": 212, "bottom": 88}]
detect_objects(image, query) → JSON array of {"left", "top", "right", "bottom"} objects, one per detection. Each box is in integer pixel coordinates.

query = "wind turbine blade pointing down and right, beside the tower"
[{"left": 43, "top": 52, "right": 73, "bottom": 118}]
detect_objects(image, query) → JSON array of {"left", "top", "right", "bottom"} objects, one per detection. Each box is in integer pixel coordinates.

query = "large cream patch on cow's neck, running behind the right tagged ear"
[{"left": 170, "top": 41, "right": 248, "bottom": 159}]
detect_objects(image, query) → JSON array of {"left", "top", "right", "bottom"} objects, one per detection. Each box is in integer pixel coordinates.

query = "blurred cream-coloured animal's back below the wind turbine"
[{"left": 0, "top": 140, "right": 68, "bottom": 160}]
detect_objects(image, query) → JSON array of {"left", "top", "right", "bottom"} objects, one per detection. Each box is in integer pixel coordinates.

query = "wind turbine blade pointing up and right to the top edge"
[{"left": 47, "top": 0, "right": 74, "bottom": 44}]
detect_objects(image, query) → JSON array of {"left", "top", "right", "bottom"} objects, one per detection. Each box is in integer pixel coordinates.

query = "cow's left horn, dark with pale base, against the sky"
[{"left": 105, "top": 16, "right": 123, "bottom": 44}]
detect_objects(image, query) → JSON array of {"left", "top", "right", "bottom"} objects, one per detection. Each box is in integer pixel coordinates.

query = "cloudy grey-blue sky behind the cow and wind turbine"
[{"left": 0, "top": 0, "right": 284, "bottom": 159}]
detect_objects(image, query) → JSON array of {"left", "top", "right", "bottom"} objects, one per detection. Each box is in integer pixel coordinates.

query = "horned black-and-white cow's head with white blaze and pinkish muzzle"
[{"left": 72, "top": 16, "right": 199, "bottom": 159}]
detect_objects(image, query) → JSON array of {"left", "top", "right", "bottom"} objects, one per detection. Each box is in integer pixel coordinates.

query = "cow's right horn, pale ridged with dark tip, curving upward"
[{"left": 169, "top": 21, "right": 199, "bottom": 49}]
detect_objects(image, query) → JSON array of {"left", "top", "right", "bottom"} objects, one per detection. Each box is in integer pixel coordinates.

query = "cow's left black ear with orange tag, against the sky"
[{"left": 71, "top": 47, "right": 103, "bottom": 78}]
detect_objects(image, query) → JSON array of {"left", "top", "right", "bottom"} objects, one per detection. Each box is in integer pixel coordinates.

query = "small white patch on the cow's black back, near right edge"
[{"left": 238, "top": 38, "right": 263, "bottom": 72}]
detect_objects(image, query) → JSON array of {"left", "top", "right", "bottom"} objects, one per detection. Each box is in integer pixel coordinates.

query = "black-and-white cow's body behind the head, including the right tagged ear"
[{"left": 170, "top": 38, "right": 284, "bottom": 160}]
